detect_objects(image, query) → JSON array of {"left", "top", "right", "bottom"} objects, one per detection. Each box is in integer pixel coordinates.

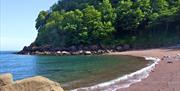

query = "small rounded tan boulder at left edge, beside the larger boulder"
[{"left": 0, "top": 73, "right": 13, "bottom": 86}]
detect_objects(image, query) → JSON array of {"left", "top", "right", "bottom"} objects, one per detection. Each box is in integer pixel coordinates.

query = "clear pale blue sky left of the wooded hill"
[{"left": 0, "top": 0, "right": 58, "bottom": 51}]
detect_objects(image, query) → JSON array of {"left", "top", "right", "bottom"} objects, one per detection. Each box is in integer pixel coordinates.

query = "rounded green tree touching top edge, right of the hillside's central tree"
[{"left": 116, "top": 0, "right": 144, "bottom": 31}]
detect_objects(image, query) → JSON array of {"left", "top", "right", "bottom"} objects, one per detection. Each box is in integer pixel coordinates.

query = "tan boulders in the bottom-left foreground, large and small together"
[{"left": 0, "top": 74, "right": 64, "bottom": 91}]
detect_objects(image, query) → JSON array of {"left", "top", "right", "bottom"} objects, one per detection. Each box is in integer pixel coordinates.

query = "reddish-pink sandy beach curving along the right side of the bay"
[{"left": 111, "top": 48, "right": 180, "bottom": 91}]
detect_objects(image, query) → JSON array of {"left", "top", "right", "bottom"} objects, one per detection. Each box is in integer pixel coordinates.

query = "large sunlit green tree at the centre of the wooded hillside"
[{"left": 83, "top": 6, "right": 114, "bottom": 44}]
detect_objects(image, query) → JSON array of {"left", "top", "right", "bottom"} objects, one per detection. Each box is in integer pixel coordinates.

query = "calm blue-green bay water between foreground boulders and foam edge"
[{"left": 0, "top": 51, "right": 148, "bottom": 89}]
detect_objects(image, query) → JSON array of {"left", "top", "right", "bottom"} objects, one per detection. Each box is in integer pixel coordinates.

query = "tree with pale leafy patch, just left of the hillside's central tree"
[{"left": 61, "top": 9, "right": 83, "bottom": 46}]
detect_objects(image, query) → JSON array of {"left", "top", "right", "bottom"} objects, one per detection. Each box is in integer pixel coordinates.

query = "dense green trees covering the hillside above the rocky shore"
[{"left": 35, "top": 0, "right": 180, "bottom": 48}]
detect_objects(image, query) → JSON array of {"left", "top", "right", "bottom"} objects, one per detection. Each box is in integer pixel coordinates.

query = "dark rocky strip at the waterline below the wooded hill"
[{"left": 18, "top": 43, "right": 131, "bottom": 56}]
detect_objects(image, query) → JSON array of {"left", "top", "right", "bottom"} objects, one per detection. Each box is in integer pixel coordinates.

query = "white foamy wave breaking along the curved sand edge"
[{"left": 71, "top": 57, "right": 160, "bottom": 91}]
